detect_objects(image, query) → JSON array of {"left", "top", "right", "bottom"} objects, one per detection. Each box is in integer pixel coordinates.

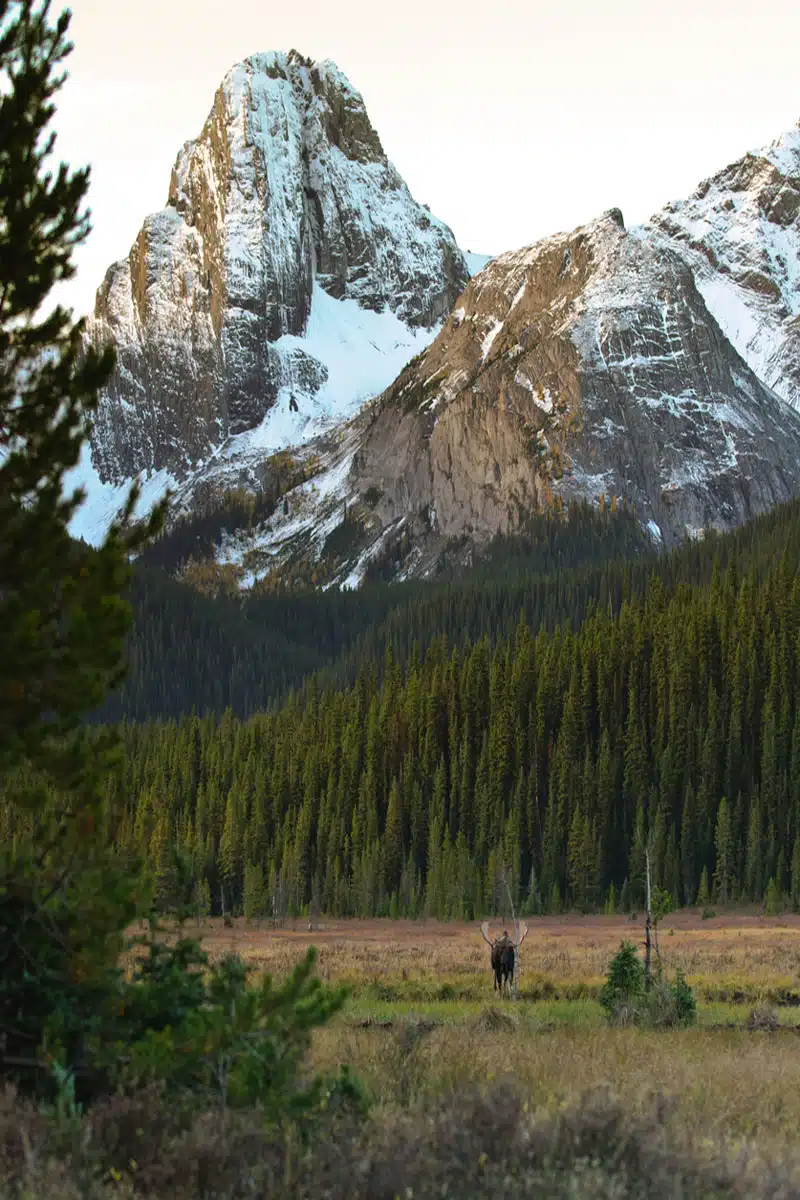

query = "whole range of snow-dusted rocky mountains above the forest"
[{"left": 77, "top": 87, "right": 800, "bottom": 576}]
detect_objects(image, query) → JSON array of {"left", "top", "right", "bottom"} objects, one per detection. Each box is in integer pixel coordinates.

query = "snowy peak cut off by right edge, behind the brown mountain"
[{"left": 651, "top": 126, "right": 800, "bottom": 408}]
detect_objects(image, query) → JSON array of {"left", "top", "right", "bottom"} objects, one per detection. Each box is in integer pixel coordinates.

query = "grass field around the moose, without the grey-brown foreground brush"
[{"left": 170, "top": 912, "right": 800, "bottom": 1146}]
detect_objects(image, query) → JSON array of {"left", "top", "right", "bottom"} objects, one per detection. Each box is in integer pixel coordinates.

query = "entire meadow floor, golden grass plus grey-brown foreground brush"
[{"left": 9, "top": 912, "right": 800, "bottom": 1200}]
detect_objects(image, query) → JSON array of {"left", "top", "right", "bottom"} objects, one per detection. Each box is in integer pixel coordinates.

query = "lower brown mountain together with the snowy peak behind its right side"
[{"left": 223, "top": 119, "right": 800, "bottom": 583}]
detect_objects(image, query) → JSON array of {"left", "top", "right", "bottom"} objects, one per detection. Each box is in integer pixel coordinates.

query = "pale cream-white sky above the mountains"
[{"left": 56, "top": 0, "right": 800, "bottom": 311}]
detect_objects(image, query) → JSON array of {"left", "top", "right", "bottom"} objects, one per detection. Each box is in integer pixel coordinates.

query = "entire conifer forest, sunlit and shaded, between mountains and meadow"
[{"left": 70, "top": 504, "right": 800, "bottom": 917}]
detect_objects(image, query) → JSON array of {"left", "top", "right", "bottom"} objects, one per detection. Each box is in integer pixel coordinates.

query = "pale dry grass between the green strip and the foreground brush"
[{"left": 314, "top": 1021, "right": 800, "bottom": 1144}]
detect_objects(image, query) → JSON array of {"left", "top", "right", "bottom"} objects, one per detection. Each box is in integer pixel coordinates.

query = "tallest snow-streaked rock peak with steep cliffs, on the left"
[{"left": 89, "top": 52, "right": 469, "bottom": 482}]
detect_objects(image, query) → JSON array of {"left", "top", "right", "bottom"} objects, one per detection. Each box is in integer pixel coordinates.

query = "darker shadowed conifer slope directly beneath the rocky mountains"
[{"left": 110, "top": 496, "right": 798, "bottom": 721}]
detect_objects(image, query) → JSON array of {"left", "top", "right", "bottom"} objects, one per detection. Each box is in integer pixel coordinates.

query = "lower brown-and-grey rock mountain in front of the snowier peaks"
[{"left": 351, "top": 210, "right": 800, "bottom": 562}]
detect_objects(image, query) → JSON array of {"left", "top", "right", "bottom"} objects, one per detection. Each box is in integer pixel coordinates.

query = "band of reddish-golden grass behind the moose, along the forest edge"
[{"left": 183, "top": 912, "right": 800, "bottom": 1004}]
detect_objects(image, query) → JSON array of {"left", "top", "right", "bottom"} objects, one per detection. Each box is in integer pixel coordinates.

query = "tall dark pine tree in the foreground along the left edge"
[{"left": 0, "top": 0, "right": 160, "bottom": 1087}]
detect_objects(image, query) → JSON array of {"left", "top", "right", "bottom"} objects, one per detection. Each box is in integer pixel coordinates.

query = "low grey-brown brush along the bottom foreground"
[{"left": 0, "top": 1082, "right": 800, "bottom": 1200}]
